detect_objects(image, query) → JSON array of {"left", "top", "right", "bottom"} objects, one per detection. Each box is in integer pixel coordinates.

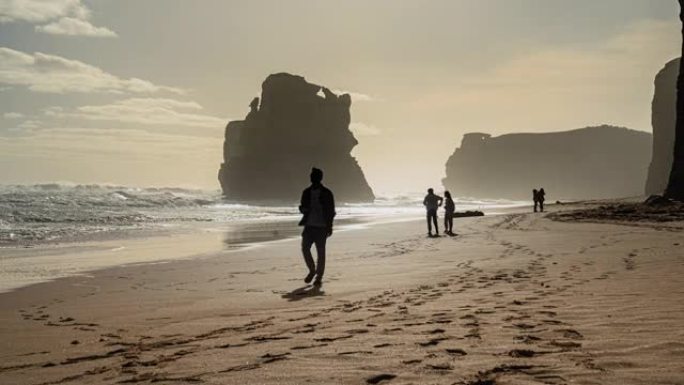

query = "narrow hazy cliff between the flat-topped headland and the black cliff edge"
[{"left": 646, "top": 59, "right": 680, "bottom": 195}]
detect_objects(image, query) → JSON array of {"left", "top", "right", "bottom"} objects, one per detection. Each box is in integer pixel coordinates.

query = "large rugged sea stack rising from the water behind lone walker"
[{"left": 219, "top": 73, "right": 375, "bottom": 202}]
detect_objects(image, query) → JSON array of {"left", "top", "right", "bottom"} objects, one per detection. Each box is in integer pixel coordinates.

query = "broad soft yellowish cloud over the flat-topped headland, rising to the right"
[{"left": 409, "top": 20, "right": 681, "bottom": 134}]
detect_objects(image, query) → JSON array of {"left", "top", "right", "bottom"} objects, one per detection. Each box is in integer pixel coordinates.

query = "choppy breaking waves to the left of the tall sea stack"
[{"left": 0, "top": 183, "right": 221, "bottom": 243}]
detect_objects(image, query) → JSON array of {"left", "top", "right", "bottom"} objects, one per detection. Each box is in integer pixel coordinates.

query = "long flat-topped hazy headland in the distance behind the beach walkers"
[{"left": 443, "top": 126, "right": 651, "bottom": 201}]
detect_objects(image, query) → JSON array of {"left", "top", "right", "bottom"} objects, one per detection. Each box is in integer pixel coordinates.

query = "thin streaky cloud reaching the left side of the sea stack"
[{"left": 45, "top": 98, "right": 227, "bottom": 130}]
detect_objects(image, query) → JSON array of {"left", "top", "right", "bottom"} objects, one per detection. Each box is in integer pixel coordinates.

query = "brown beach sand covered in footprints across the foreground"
[{"left": 0, "top": 207, "right": 684, "bottom": 385}]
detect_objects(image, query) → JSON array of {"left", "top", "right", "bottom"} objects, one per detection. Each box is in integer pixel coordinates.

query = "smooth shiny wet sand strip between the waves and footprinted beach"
[{"left": 0, "top": 216, "right": 368, "bottom": 293}]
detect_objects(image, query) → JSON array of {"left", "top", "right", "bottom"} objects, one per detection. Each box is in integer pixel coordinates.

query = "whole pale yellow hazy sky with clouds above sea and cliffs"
[{"left": 0, "top": 0, "right": 681, "bottom": 193}]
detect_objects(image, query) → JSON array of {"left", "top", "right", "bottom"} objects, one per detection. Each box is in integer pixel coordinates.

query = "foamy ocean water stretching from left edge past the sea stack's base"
[{"left": 0, "top": 184, "right": 519, "bottom": 247}]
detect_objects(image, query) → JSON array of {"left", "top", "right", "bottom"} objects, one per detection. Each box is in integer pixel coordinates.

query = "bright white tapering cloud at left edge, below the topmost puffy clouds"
[{"left": 0, "top": 47, "right": 183, "bottom": 94}]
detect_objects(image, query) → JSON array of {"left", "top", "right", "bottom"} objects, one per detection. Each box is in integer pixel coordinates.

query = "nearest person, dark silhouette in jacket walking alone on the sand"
[{"left": 299, "top": 167, "right": 335, "bottom": 286}]
